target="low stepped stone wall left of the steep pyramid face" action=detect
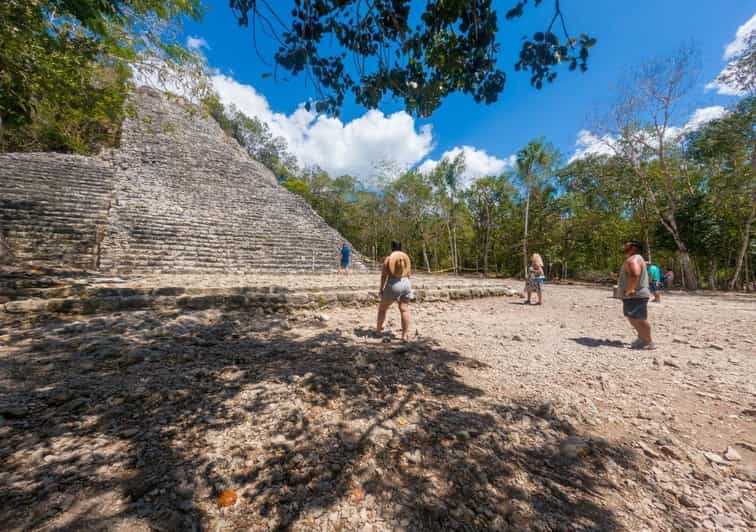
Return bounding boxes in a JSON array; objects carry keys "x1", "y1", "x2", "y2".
[{"x1": 0, "y1": 153, "x2": 114, "y2": 270}]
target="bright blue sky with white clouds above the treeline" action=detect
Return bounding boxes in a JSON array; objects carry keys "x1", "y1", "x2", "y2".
[{"x1": 179, "y1": 0, "x2": 756, "y2": 183}]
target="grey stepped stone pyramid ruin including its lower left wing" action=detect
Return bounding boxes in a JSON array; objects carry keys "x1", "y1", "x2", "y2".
[{"x1": 0, "y1": 88, "x2": 366, "y2": 274}]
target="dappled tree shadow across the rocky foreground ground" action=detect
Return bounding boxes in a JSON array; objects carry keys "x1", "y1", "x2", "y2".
[{"x1": 0, "y1": 312, "x2": 684, "y2": 530}]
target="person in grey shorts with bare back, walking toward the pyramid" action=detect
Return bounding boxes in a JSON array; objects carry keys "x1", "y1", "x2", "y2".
[{"x1": 375, "y1": 240, "x2": 412, "y2": 342}]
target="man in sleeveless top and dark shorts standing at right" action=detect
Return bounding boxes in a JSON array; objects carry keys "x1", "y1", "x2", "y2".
[{"x1": 619, "y1": 240, "x2": 656, "y2": 349}]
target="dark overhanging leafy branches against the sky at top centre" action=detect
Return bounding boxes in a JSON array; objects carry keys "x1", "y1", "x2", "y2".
[{"x1": 230, "y1": 0, "x2": 596, "y2": 116}]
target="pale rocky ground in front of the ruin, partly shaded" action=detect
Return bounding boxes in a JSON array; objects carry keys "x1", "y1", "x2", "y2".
[{"x1": 0, "y1": 280, "x2": 756, "y2": 531}]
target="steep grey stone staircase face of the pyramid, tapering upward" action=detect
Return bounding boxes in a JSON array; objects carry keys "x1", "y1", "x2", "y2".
[{"x1": 102, "y1": 90, "x2": 370, "y2": 273}]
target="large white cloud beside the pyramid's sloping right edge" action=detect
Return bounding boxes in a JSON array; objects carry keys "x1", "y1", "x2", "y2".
[{"x1": 211, "y1": 74, "x2": 433, "y2": 179}]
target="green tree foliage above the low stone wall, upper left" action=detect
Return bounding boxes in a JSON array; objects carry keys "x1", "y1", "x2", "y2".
[{"x1": 0, "y1": 0, "x2": 200, "y2": 152}]
